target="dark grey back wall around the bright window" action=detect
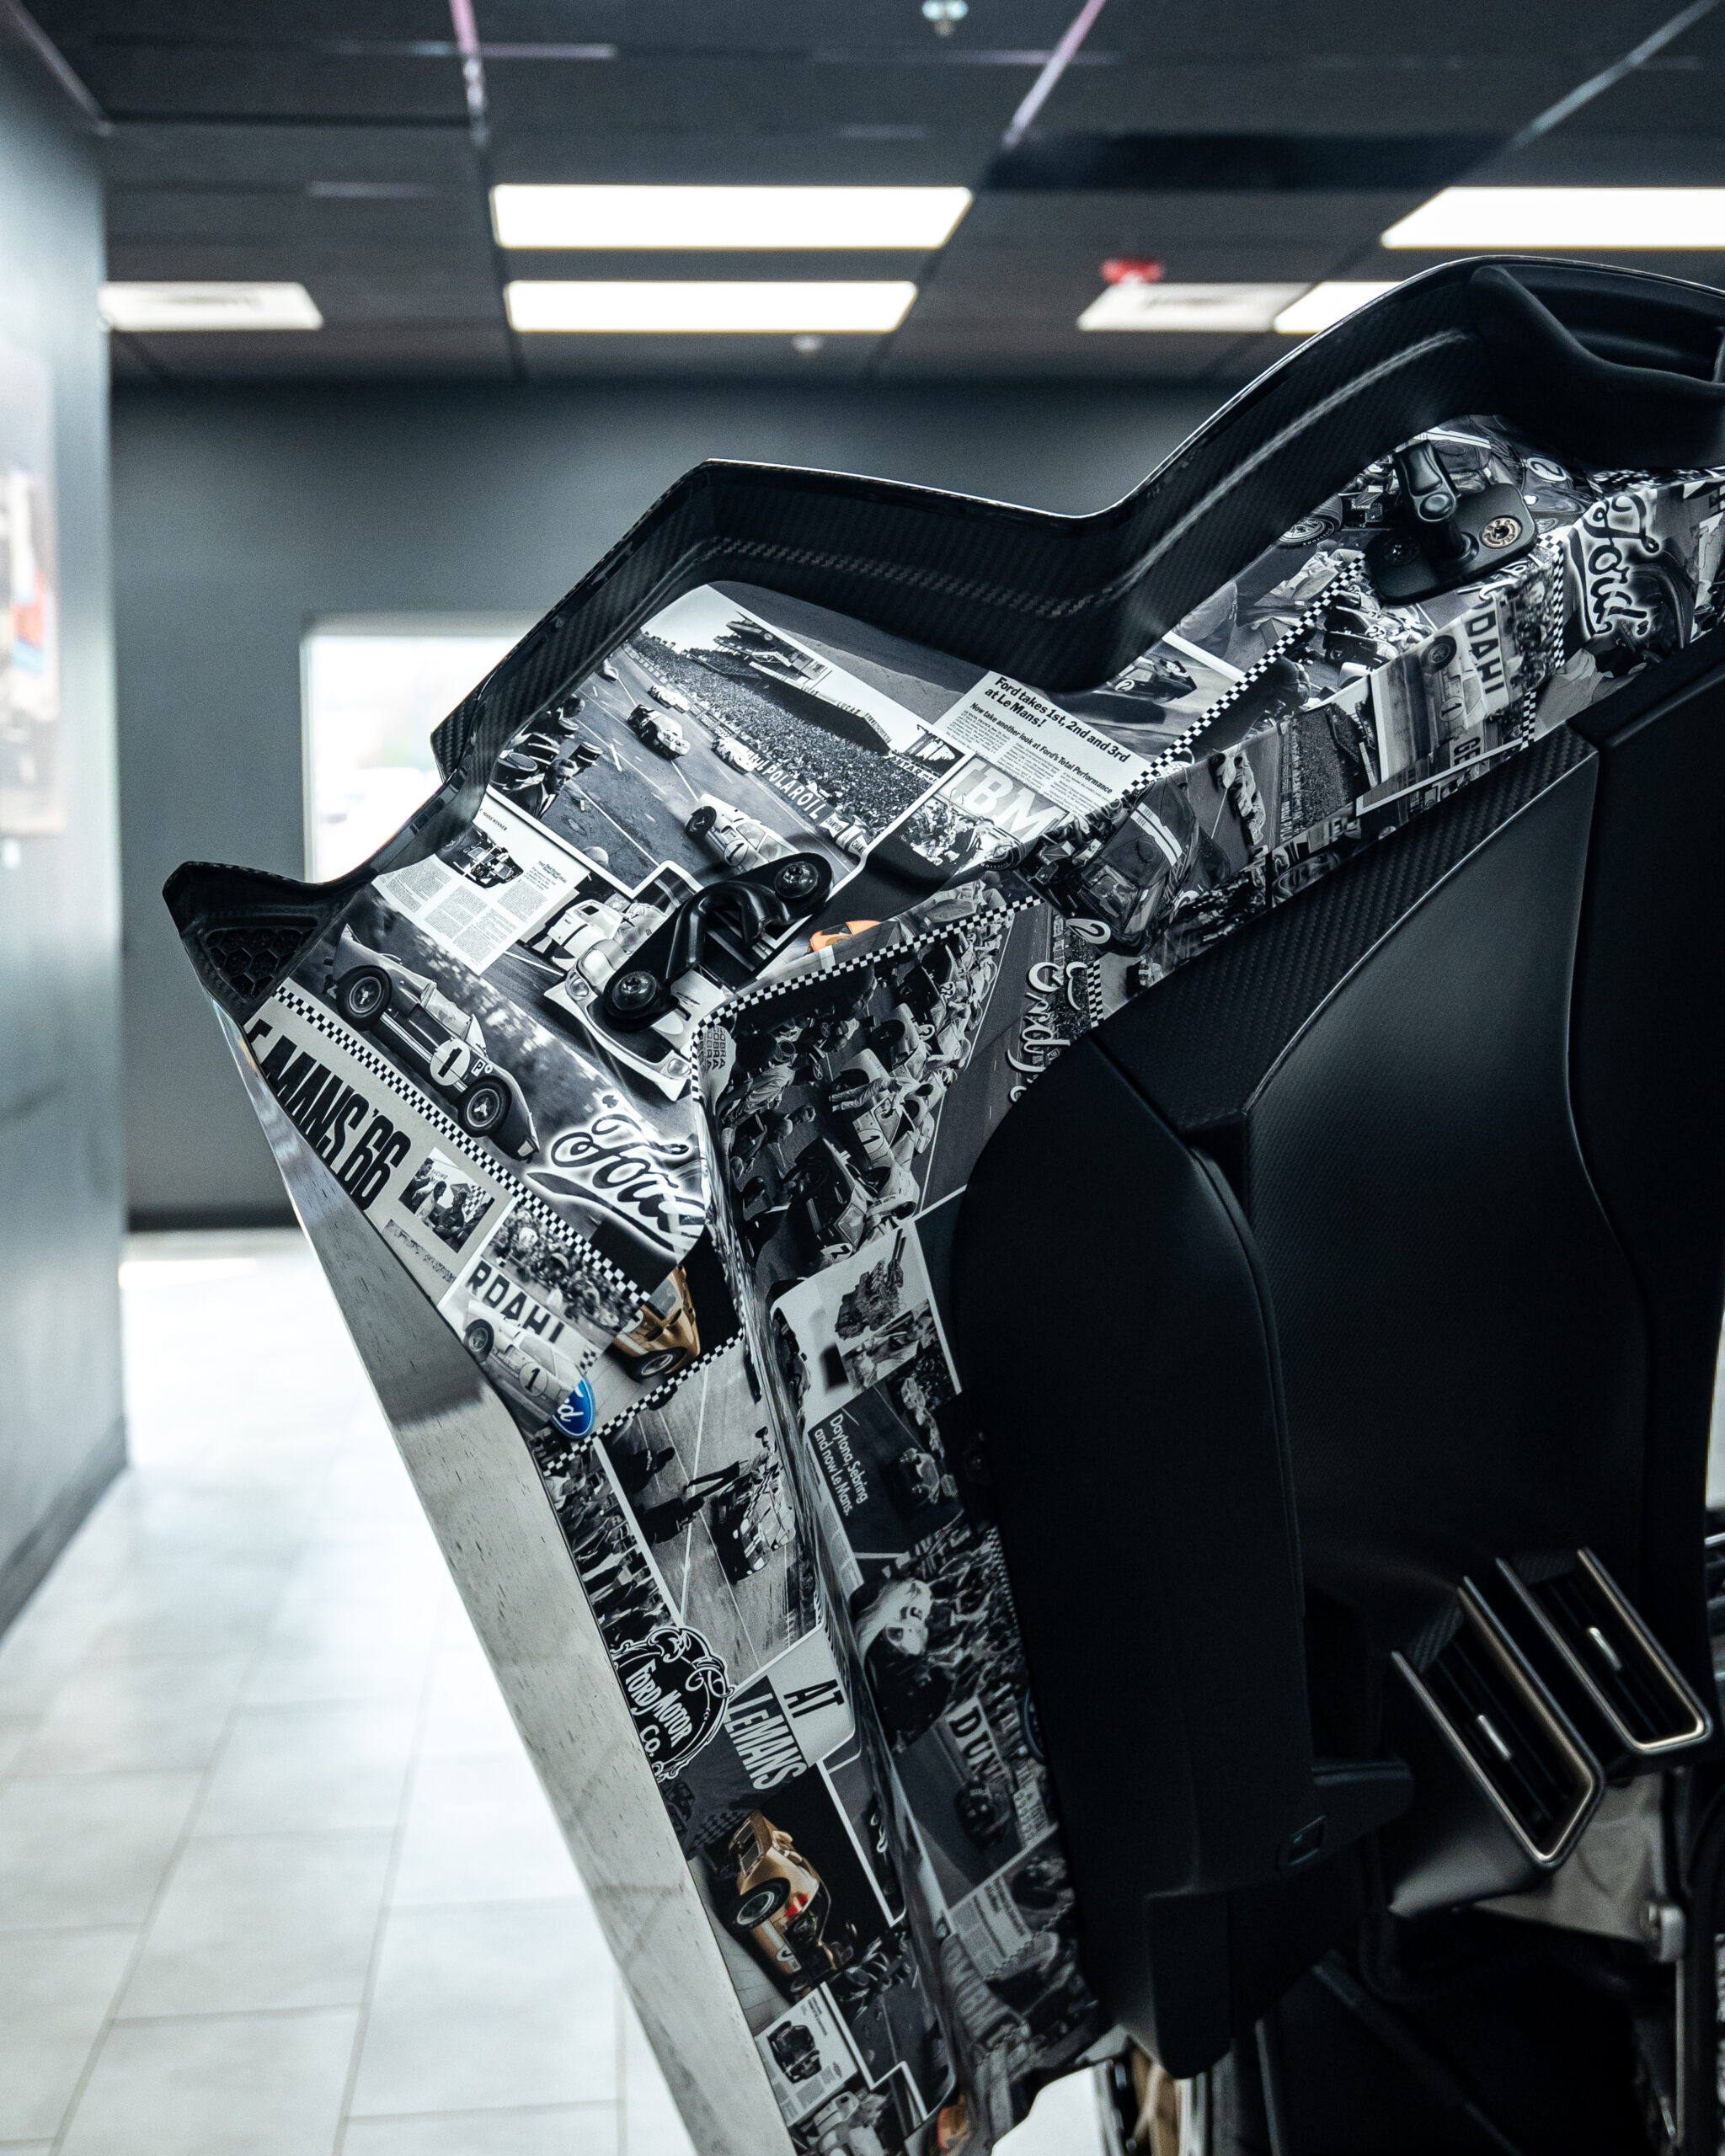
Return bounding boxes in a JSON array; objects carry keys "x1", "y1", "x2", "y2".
[{"x1": 115, "y1": 384, "x2": 1210, "y2": 1220}]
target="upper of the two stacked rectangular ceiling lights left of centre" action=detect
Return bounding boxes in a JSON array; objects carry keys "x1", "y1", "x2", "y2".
[{"x1": 492, "y1": 185, "x2": 970, "y2": 253}]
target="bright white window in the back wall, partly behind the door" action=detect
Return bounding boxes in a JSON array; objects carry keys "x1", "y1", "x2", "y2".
[{"x1": 300, "y1": 615, "x2": 531, "y2": 884}]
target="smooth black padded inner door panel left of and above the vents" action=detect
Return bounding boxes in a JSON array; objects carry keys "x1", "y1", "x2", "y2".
[{"x1": 953, "y1": 643, "x2": 1725, "y2": 2072}]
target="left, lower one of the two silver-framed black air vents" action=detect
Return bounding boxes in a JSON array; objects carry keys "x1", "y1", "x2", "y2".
[{"x1": 1395, "y1": 1580, "x2": 1605, "y2": 1870}]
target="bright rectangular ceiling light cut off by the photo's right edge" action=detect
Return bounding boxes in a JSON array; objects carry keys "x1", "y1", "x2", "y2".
[{"x1": 1385, "y1": 188, "x2": 1725, "y2": 254}]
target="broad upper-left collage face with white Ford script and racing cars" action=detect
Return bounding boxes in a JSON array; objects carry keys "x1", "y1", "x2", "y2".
[{"x1": 252, "y1": 586, "x2": 1172, "y2": 1449}]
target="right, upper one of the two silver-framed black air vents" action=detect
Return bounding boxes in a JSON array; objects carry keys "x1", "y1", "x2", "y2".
[{"x1": 1498, "y1": 1550, "x2": 1712, "y2": 1759}]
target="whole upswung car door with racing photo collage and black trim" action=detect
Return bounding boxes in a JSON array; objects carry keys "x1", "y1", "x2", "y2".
[{"x1": 166, "y1": 263, "x2": 1725, "y2": 2152}]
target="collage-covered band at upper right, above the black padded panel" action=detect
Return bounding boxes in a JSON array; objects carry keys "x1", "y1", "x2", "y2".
[{"x1": 1027, "y1": 419, "x2": 1725, "y2": 1013}]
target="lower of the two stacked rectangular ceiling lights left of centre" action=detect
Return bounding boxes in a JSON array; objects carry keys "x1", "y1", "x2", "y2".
[{"x1": 505, "y1": 278, "x2": 916, "y2": 336}]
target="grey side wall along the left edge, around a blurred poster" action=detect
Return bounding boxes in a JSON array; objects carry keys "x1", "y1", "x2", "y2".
[{"x1": 0, "y1": 39, "x2": 125, "y2": 1625}]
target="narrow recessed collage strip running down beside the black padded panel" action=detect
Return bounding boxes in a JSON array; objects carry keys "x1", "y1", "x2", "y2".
[{"x1": 703, "y1": 931, "x2": 1104, "y2": 2149}]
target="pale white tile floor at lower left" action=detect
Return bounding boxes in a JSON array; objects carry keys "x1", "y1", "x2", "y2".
[{"x1": 0, "y1": 1233, "x2": 1097, "y2": 2156}]
